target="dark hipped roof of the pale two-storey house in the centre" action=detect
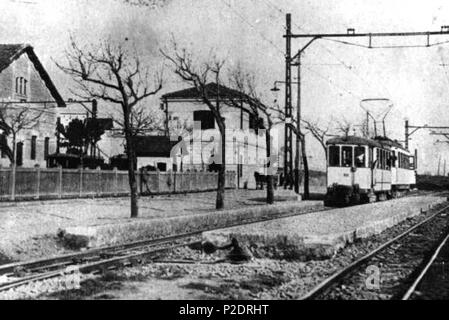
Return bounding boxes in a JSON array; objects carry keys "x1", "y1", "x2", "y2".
[{"x1": 162, "y1": 82, "x2": 245, "y2": 99}]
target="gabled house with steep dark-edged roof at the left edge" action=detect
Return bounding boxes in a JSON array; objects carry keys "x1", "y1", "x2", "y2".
[{"x1": 0, "y1": 44, "x2": 65, "y2": 167}]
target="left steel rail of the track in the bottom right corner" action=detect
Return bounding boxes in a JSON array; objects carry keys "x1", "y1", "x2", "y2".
[{"x1": 299, "y1": 205, "x2": 449, "y2": 300}]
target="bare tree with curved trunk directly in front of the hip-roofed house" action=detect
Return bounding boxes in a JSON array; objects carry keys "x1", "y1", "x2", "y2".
[{"x1": 161, "y1": 42, "x2": 226, "y2": 209}]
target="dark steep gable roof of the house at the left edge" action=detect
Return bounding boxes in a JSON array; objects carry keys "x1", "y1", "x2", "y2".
[{"x1": 0, "y1": 44, "x2": 66, "y2": 107}]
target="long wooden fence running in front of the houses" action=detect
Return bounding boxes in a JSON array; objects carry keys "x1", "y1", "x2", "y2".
[{"x1": 0, "y1": 168, "x2": 236, "y2": 200}]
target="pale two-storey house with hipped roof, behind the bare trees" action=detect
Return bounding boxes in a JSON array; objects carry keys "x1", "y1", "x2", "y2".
[{"x1": 161, "y1": 83, "x2": 266, "y2": 188}]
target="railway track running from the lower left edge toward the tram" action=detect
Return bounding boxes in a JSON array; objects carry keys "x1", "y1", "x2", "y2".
[{"x1": 0, "y1": 193, "x2": 440, "y2": 292}]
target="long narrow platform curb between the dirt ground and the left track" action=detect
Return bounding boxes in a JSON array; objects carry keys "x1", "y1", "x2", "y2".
[{"x1": 59, "y1": 201, "x2": 321, "y2": 249}]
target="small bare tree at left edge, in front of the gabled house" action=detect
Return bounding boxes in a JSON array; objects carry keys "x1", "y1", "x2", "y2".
[{"x1": 0, "y1": 102, "x2": 45, "y2": 166}]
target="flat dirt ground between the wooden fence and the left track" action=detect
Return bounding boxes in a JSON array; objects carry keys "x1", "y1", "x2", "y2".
[{"x1": 0, "y1": 190, "x2": 322, "y2": 263}]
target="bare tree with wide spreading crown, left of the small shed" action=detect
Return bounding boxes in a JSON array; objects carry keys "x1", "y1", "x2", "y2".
[{"x1": 56, "y1": 39, "x2": 162, "y2": 218}]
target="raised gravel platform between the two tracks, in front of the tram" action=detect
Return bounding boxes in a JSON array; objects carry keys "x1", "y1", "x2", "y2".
[{"x1": 203, "y1": 196, "x2": 445, "y2": 261}]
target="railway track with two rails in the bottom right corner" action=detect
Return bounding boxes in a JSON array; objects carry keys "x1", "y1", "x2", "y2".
[{"x1": 300, "y1": 205, "x2": 449, "y2": 300}]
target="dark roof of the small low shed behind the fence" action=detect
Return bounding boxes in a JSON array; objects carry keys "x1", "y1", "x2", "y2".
[{"x1": 134, "y1": 136, "x2": 178, "y2": 158}]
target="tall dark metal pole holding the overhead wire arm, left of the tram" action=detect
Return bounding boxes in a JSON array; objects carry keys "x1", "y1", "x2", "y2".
[{"x1": 284, "y1": 13, "x2": 292, "y2": 189}]
